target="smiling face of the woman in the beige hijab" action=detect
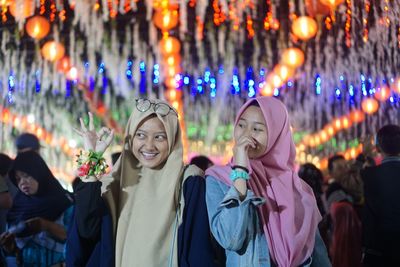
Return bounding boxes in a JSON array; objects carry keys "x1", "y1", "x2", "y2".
[{"x1": 132, "y1": 117, "x2": 169, "y2": 169}]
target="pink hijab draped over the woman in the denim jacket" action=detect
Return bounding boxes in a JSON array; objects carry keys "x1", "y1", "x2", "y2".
[{"x1": 206, "y1": 97, "x2": 321, "y2": 267}]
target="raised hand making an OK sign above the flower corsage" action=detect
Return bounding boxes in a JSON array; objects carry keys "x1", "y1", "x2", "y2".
[{"x1": 74, "y1": 112, "x2": 114, "y2": 153}]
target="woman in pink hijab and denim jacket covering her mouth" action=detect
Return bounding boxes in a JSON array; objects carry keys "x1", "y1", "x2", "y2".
[{"x1": 206, "y1": 97, "x2": 331, "y2": 267}]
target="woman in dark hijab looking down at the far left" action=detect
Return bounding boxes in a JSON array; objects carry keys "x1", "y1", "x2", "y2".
[{"x1": 0, "y1": 151, "x2": 73, "y2": 267}]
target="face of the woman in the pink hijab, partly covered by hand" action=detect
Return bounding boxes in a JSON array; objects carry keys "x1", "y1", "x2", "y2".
[{"x1": 234, "y1": 105, "x2": 268, "y2": 159}]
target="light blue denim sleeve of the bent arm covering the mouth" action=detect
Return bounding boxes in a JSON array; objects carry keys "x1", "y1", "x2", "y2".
[{"x1": 206, "y1": 176, "x2": 265, "y2": 251}]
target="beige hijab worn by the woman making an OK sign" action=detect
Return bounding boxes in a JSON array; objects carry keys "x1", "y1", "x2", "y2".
[{"x1": 102, "y1": 100, "x2": 201, "y2": 267}]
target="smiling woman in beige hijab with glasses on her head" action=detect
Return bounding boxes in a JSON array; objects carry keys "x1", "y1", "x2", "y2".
[{"x1": 67, "y1": 99, "x2": 222, "y2": 267}]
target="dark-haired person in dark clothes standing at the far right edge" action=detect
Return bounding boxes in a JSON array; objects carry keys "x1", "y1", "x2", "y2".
[{"x1": 361, "y1": 124, "x2": 400, "y2": 267}]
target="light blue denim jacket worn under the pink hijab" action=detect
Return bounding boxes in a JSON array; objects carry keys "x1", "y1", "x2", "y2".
[{"x1": 206, "y1": 176, "x2": 331, "y2": 267}]
